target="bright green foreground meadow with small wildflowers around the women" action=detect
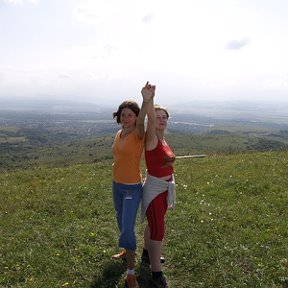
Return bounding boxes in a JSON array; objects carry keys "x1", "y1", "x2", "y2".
[{"x1": 0, "y1": 152, "x2": 288, "y2": 288}]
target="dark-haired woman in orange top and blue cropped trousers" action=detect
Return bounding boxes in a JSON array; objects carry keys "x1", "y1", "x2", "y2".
[{"x1": 112, "y1": 82, "x2": 155, "y2": 288}]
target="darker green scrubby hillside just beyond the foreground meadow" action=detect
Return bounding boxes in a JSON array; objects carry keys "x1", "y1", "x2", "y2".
[{"x1": 0, "y1": 130, "x2": 288, "y2": 171}]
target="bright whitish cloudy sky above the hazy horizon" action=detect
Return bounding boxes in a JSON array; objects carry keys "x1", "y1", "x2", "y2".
[{"x1": 0, "y1": 0, "x2": 288, "y2": 105}]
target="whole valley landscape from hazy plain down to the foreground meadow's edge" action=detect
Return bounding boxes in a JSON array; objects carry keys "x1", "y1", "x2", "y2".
[{"x1": 0, "y1": 109, "x2": 288, "y2": 171}]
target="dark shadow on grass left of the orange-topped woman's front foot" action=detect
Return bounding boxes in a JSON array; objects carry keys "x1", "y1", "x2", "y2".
[{"x1": 90, "y1": 261, "x2": 127, "y2": 288}]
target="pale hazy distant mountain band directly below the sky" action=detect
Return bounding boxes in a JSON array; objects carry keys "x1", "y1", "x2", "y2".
[{"x1": 0, "y1": 97, "x2": 288, "y2": 124}]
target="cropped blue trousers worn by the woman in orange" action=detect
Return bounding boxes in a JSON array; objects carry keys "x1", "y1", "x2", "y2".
[{"x1": 112, "y1": 181, "x2": 142, "y2": 251}]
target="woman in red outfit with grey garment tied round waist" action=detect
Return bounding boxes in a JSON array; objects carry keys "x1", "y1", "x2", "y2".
[{"x1": 142, "y1": 92, "x2": 175, "y2": 287}]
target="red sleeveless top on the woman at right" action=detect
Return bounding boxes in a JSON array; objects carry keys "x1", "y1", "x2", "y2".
[{"x1": 145, "y1": 139, "x2": 175, "y2": 177}]
